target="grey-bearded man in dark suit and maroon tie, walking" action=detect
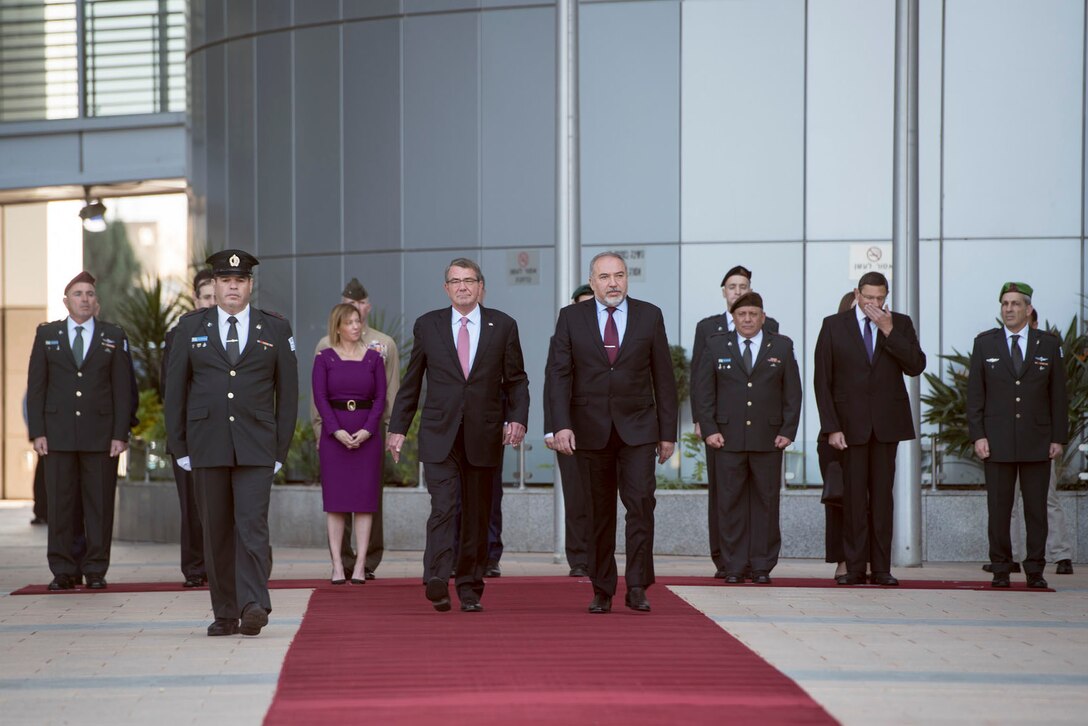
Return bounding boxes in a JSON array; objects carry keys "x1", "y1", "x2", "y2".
[{"x1": 547, "y1": 253, "x2": 677, "y2": 614}]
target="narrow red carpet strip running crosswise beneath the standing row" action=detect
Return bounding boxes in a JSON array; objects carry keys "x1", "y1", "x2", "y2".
[{"x1": 11, "y1": 576, "x2": 1054, "y2": 596}]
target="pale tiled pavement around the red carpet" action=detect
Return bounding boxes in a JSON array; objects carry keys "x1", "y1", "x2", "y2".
[{"x1": 0, "y1": 502, "x2": 1088, "y2": 726}]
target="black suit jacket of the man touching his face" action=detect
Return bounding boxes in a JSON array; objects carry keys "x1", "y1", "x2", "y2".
[{"x1": 813, "y1": 308, "x2": 926, "y2": 445}]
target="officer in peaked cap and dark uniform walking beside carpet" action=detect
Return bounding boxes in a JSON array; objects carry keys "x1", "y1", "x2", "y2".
[{"x1": 165, "y1": 249, "x2": 298, "y2": 636}]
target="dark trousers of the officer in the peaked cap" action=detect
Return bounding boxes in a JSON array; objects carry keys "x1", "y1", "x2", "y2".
[{"x1": 193, "y1": 466, "x2": 272, "y2": 618}]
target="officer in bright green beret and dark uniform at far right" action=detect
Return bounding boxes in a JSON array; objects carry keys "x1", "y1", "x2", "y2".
[{"x1": 967, "y1": 282, "x2": 1068, "y2": 589}]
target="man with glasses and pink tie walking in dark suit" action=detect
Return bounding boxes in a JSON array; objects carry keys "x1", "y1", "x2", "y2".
[{"x1": 386, "y1": 258, "x2": 529, "y2": 613}]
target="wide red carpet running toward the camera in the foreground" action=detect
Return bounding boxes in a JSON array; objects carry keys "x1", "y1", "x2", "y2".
[{"x1": 265, "y1": 577, "x2": 836, "y2": 725}]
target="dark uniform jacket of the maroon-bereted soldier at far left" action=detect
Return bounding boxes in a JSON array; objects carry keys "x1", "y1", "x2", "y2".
[{"x1": 26, "y1": 318, "x2": 133, "y2": 452}]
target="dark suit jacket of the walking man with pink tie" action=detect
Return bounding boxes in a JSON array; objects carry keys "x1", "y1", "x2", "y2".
[{"x1": 390, "y1": 305, "x2": 529, "y2": 467}]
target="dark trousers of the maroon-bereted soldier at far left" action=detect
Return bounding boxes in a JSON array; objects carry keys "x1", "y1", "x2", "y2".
[{"x1": 45, "y1": 451, "x2": 118, "y2": 577}]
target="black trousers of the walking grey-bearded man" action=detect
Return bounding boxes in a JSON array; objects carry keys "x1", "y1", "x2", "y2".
[{"x1": 574, "y1": 427, "x2": 657, "y2": 596}]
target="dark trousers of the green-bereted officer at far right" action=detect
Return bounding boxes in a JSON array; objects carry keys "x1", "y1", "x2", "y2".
[{"x1": 984, "y1": 460, "x2": 1050, "y2": 575}]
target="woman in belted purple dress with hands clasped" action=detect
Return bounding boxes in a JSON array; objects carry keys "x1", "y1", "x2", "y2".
[{"x1": 313, "y1": 305, "x2": 385, "y2": 585}]
